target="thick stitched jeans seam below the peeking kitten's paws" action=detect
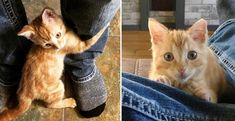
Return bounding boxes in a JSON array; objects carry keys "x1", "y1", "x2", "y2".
[{"x1": 122, "y1": 87, "x2": 204, "y2": 121}]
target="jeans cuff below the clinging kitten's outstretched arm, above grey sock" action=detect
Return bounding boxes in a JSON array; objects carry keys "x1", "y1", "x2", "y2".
[{"x1": 64, "y1": 29, "x2": 108, "y2": 81}]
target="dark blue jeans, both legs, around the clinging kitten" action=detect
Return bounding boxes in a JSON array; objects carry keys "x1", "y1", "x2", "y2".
[{"x1": 0, "y1": 0, "x2": 120, "y2": 86}]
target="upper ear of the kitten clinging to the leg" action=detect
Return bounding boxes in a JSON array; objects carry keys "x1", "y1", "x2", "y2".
[{"x1": 42, "y1": 8, "x2": 57, "y2": 24}]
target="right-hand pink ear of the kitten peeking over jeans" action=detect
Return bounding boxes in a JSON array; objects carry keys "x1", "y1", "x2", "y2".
[{"x1": 189, "y1": 19, "x2": 208, "y2": 43}]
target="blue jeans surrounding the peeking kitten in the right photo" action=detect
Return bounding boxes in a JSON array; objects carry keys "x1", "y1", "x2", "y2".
[{"x1": 122, "y1": 19, "x2": 235, "y2": 121}]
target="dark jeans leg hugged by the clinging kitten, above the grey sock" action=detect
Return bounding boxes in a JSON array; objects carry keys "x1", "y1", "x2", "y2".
[{"x1": 61, "y1": 0, "x2": 120, "y2": 80}]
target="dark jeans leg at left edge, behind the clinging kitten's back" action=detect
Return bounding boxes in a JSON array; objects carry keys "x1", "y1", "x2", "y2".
[{"x1": 0, "y1": 0, "x2": 31, "y2": 110}]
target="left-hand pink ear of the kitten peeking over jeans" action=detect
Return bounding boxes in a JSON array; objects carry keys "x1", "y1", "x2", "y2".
[{"x1": 148, "y1": 18, "x2": 168, "y2": 44}]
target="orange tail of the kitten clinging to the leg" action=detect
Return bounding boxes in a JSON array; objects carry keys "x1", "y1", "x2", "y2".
[{"x1": 0, "y1": 98, "x2": 32, "y2": 121}]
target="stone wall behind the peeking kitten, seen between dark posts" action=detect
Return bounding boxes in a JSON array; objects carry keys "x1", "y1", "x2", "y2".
[{"x1": 122, "y1": 0, "x2": 219, "y2": 25}]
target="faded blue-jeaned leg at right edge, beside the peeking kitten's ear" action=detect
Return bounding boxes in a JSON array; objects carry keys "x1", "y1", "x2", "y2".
[{"x1": 208, "y1": 0, "x2": 235, "y2": 89}]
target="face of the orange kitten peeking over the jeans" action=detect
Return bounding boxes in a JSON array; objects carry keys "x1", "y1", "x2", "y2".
[{"x1": 149, "y1": 19, "x2": 208, "y2": 82}]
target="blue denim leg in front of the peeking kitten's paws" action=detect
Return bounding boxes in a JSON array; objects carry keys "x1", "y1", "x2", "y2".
[{"x1": 122, "y1": 73, "x2": 235, "y2": 121}]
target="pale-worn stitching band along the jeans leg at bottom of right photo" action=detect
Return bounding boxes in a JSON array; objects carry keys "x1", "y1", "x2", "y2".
[{"x1": 122, "y1": 87, "x2": 204, "y2": 121}]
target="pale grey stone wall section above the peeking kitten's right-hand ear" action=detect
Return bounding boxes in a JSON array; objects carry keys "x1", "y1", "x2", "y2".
[{"x1": 184, "y1": 0, "x2": 219, "y2": 25}]
